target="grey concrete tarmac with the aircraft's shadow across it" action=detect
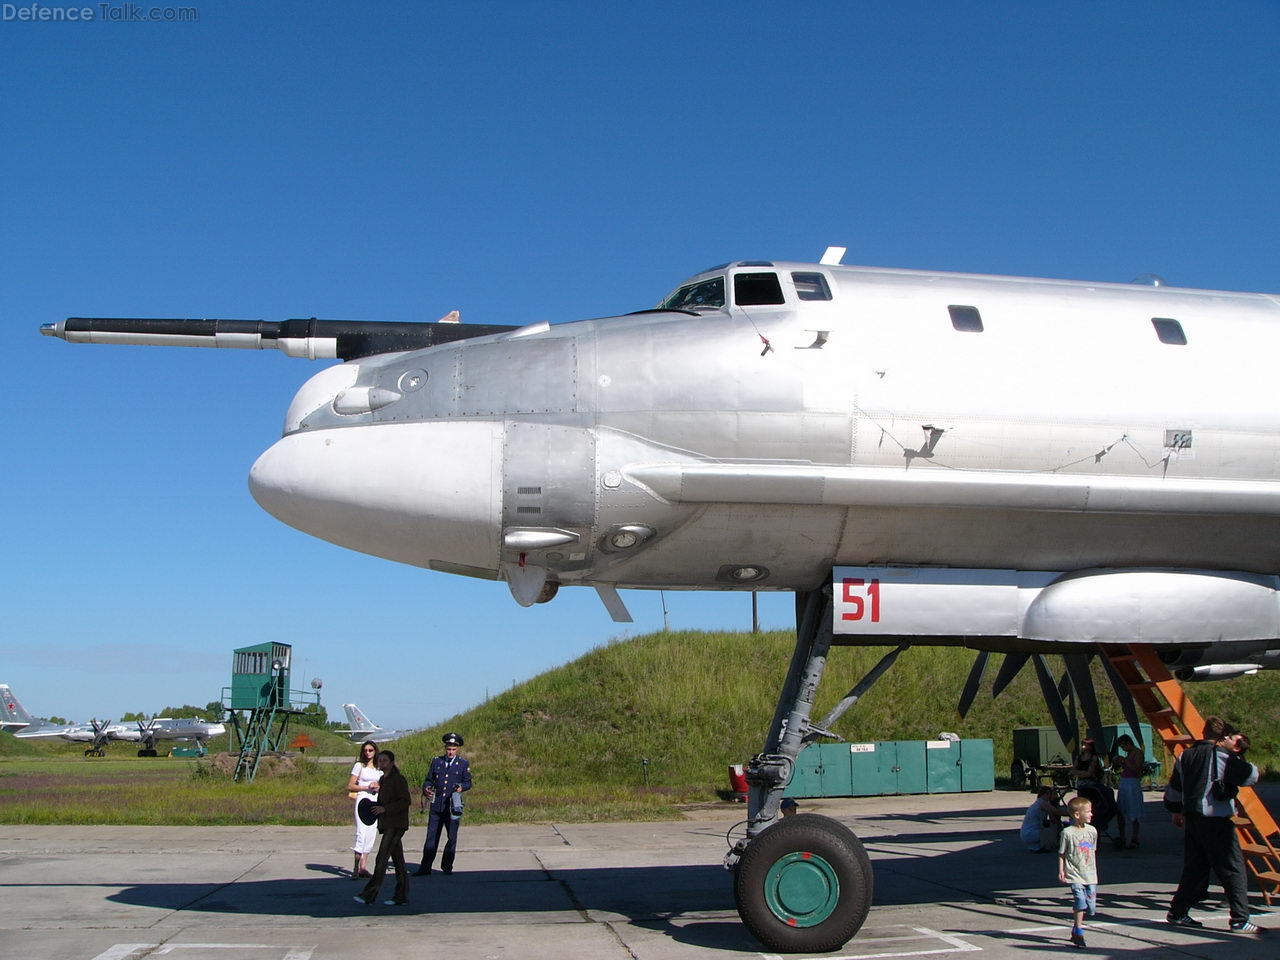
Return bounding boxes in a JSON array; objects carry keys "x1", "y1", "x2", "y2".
[{"x1": 0, "y1": 790, "x2": 1280, "y2": 960}]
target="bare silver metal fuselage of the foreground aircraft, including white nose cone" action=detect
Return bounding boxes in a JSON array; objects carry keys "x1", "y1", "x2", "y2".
[{"x1": 251, "y1": 264, "x2": 1280, "y2": 609}]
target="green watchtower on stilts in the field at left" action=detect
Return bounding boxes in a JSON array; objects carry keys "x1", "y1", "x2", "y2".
[{"x1": 223, "y1": 643, "x2": 320, "y2": 781}]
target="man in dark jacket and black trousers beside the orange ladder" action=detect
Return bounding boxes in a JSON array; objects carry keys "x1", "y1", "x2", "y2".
[{"x1": 1165, "y1": 717, "x2": 1261, "y2": 933}]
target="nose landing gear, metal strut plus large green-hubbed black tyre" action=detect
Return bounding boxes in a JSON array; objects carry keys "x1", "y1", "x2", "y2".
[{"x1": 724, "y1": 586, "x2": 875, "y2": 954}]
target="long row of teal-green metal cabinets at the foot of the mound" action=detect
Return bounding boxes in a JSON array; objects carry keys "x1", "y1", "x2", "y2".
[{"x1": 785, "y1": 740, "x2": 996, "y2": 797}]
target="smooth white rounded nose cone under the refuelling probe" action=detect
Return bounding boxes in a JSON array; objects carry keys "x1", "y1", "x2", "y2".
[{"x1": 248, "y1": 421, "x2": 502, "y2": 570}]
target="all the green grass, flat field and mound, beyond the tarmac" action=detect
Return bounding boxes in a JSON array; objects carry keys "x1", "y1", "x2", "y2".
[{"x1": 0, "y1": 632, "x2": 1280, "y2": 824}]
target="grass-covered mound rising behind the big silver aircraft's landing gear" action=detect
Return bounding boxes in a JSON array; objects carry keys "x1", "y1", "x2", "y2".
[{"x1": 384, "y1": 631, "x2": 1280, "y2": 820}]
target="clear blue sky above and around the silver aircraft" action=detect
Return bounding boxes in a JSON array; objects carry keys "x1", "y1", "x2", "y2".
[{"x1": 0, "y1": 0, "x2": 1280, "y2": 724}]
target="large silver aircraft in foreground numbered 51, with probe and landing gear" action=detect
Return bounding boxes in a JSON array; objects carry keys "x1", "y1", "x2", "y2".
[{"x1": 41, "y1": 256, "x2": 1280, "y2": 951}]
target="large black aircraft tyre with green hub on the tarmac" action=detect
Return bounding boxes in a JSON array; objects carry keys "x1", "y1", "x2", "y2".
[{"x1": 733, "y1": 814, "x2": 872, "y2": 954}]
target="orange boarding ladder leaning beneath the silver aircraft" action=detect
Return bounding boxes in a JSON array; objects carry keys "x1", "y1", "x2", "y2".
[{"x1": 1102, "y1": 644, "x2": 1280, "y2": 906}]
